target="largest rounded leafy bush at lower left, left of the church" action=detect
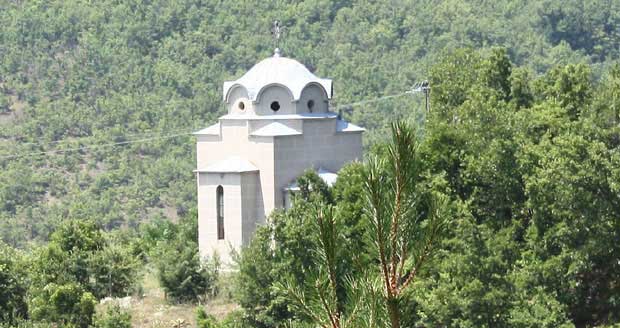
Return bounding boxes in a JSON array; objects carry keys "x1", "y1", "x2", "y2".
[{"x1": 19, "y1": 220, "x2": 139, "y2": 327}]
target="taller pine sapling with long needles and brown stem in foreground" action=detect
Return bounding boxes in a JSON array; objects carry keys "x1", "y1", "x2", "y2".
[{"x1": 364, "y1": 123, "x2": 449, "y2": 328}]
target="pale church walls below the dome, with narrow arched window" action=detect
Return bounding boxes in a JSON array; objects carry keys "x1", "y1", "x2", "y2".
[{"x1": 197, "y1": 115, "x2": 362, "y2": 264}]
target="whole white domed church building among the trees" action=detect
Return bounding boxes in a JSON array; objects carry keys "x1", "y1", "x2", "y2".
[{"x1": 194, "y1": 49, "x2": 364, "y2": 266}]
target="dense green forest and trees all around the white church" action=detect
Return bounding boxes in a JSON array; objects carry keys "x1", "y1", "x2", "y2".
[{"x1": 0, "y1": 0, "x2": 620, "y2": 328}]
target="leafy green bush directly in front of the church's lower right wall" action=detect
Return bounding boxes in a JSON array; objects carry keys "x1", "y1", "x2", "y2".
[{"x1": 235, "y1": 168, "x2": 368, "y2": 327}]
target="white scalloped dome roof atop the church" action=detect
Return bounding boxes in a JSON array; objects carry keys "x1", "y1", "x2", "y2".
[{"x1": 224, "y1": 53, "x2": 332, "y2": 102}]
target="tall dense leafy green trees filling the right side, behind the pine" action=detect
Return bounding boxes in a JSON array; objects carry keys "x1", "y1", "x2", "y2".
[{"x1": 413, "y1": 47, "x2": 620, "y2": 327}]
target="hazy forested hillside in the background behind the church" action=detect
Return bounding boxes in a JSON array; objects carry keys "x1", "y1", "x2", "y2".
[{"x1": 0, "y1": 0, "x2": 620, "y2": 245}]
